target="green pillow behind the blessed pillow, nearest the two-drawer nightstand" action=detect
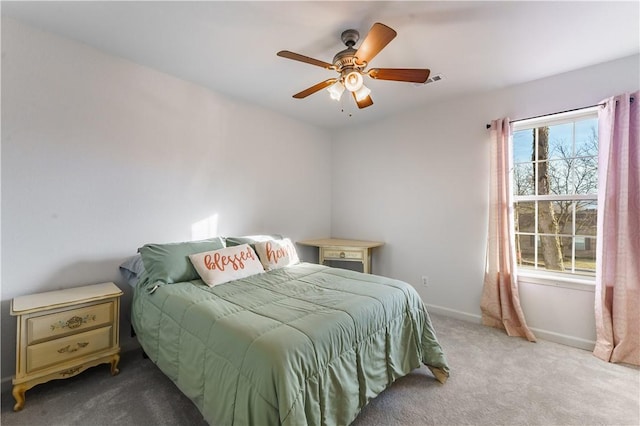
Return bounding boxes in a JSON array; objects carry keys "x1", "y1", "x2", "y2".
[{"x1": 138, "y1": 237, "x2": 224, "y2": 284}]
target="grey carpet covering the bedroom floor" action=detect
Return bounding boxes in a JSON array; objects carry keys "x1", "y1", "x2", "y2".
[{"x1": 1, "y1": 315, "x2": 640, "y2": 426}]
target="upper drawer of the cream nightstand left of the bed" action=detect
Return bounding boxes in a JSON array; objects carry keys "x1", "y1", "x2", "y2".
[{"x1": 27, "y1": 302, "x2": 113, "y2": 345}]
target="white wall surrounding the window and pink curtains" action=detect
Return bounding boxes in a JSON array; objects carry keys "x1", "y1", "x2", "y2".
[{"x1": 331, "y1": 56, "x2": 640, "y2": 347}]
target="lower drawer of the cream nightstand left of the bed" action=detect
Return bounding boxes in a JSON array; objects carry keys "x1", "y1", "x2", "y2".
[{"x1": 27, "y1": 326, "x2": 112, "y2": 372}]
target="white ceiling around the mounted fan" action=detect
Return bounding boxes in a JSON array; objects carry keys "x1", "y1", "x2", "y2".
[{"x1": 1, "y1": 1, "x2": 640, "y2": 128}]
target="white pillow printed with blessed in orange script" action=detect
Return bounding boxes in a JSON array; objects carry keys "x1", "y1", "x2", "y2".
[{"x1": 189, "y1": 244, "x2": 264, "y2": 287}]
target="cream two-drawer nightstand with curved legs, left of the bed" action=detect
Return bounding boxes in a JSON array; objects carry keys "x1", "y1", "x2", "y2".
[{"x1": 11, "y1": 283, "x2": 122, "y2": 411}]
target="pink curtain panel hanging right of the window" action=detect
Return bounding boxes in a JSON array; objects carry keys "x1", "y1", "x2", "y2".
[{"x1": 593, "y1": 92, "x2": 640, "y2": 365}]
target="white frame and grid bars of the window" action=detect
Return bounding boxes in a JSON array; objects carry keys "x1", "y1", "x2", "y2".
[{"x1": 509, "y1": 106, "x2": 599, "y2": 291}]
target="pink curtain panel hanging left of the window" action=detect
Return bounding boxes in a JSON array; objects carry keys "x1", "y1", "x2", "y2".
[{"x1": 480, "y1": 118, "x2": 536, "y2": 342}]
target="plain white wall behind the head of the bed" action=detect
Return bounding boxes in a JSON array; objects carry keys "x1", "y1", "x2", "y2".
[{"x1": 1, "y1": 19, "x2": 331, "y2": 378}]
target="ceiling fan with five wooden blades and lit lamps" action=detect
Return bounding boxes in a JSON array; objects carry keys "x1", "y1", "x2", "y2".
[{"x1": 277, "y1": 22, "x2": 430, "y2": 108}]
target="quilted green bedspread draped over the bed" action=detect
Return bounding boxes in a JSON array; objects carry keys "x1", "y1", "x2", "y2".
[{"x1": 132, "y1": 263, "x2": 449, "y2": 425}]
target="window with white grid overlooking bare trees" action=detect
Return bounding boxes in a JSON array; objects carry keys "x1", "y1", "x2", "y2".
[{"x1": 512, "y1": 107, "x2": 598, "y2": 277}]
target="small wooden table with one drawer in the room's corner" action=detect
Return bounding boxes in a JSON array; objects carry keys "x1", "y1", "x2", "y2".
[{"x1": 298, "y1": 238, "x2": 384, "y2": 274}]
